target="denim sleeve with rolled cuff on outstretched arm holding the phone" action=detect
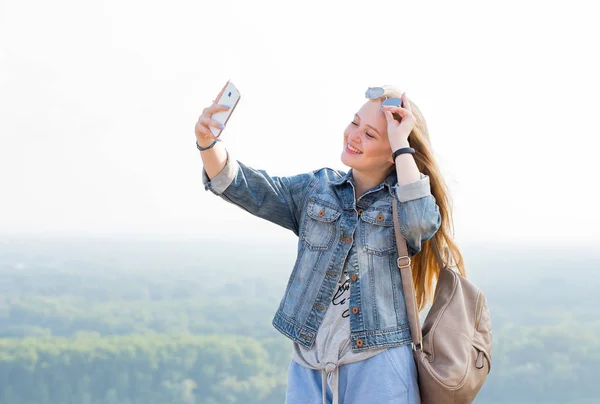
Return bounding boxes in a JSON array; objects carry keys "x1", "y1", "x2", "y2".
[{"x1": 202, "y1": 151, "x2": 315, "y2": 235}]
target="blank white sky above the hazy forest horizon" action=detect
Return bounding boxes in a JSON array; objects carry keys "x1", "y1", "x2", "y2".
[{"x1": 0, "y1": 0, "x2": 600, "y2": 242}]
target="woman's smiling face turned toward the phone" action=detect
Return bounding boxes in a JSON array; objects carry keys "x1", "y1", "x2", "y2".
[{"x1": 341, "y1": 100, "x2": 394, "y2": 175}]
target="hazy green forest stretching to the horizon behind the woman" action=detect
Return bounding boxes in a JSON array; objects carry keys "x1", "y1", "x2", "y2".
[{"x1": 0, "y1": 239, "x2": 600, "y2": 404}]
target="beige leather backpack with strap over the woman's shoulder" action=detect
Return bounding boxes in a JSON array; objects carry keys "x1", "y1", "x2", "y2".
[{"x1": 394, "y1": 198, "x2": 492, "y2": 404}]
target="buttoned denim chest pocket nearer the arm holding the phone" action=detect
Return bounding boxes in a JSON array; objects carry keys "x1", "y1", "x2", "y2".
[{"x1": 302, "y1": 198, "x2": 342, "y2": 250}]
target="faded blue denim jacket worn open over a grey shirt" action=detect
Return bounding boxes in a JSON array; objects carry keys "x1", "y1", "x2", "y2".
[{"x1": 202, "y1": 152, "x2": 441, "y2": 352}]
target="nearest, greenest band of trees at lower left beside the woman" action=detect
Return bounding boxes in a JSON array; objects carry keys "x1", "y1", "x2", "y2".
[{"x1": 0, "y1": 334, "x2": 289, "y2": 404}]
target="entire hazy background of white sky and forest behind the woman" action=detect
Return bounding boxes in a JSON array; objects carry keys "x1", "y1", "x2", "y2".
[{"x1": 0, "y1": 0, "x2": 600, "y2": 404}]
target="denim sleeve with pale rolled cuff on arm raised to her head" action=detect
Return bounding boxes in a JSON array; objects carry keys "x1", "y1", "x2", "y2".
[{"x1": 395, "y1": 173, "x2": 442, "y2": 256}]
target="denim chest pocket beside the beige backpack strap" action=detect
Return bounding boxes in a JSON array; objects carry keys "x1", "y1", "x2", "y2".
[{"x1": 360, "y1": 209, "x2": 396, "y2": 255}]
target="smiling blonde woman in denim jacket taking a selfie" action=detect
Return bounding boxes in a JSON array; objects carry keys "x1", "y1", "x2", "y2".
[{"x1": 195, "y1": 86, "x2": 464, "y2": 404}]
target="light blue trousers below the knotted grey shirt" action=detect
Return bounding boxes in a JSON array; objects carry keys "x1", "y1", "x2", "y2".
[{"x1": 285, "y1": 345, "x2": 421, "y2": 404}]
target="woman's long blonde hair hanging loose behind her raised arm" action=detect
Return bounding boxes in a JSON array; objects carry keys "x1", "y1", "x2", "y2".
[{"x1": 381, "y1": 85, "x2": 466, "y2": 311}]
